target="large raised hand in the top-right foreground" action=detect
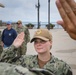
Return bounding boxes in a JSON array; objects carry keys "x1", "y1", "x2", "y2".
[{"x1": 56, "y1": 0, "x2": 76, "y2": 40}]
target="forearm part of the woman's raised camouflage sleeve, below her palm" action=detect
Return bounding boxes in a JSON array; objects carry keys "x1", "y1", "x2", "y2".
[{"x1": 0, "y1": 45, "x2": 16, "y2": 62}]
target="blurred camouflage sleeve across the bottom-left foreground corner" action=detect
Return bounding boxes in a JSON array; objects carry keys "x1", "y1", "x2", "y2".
[{"x1": 0, "y1": 63, "x2": 37, "y2": 75}]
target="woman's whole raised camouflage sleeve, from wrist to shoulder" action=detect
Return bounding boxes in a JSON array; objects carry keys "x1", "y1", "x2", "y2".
[{"x1": 0, "y1": 45, "x2": 31, "y2": 68}]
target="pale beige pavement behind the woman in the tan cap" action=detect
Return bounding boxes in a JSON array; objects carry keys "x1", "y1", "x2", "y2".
[{"x1": 26, "y1": 29, "x2": 76, "y2": 75}]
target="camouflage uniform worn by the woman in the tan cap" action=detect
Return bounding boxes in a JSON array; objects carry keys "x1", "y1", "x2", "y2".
[{"x1": 1, "y1": 46, "x2": 72, "y2": 75}]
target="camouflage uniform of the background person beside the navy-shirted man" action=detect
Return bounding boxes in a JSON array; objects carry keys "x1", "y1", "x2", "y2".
[{"x1": 16, "y1": 26, "x2": 30, "y2": 56}]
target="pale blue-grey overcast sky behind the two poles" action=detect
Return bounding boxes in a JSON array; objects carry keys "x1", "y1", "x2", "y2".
[{"x1": 0, "y1": 0, "x2": 61, "y2": 22}]
